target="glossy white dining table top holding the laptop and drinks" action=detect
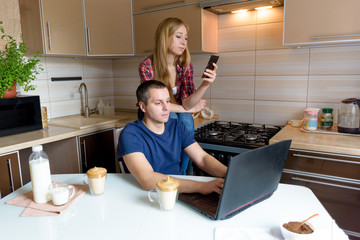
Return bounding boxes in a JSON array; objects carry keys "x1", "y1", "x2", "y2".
[{"x1": 0, "y1": 174, "x2": 344, "y2": 240}]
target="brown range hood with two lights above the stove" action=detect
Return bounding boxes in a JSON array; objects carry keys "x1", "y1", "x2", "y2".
[{"x1": 200, "y1": 0, "x2": 284, "y2": 14}]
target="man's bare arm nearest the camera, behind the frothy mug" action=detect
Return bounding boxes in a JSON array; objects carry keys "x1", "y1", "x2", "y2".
[{"x1": 123, "y1": 152, "x2": 226, "y2": 194}]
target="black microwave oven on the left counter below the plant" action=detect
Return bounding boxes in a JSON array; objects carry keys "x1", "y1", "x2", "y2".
[{"x1": 0, "y1": 96, "x2": 42, "y2": 137}]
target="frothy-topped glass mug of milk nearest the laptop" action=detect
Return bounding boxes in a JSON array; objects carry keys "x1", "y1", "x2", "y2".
[{"x1": 148, "y1": 176, "x2": 179, "y2": 210}]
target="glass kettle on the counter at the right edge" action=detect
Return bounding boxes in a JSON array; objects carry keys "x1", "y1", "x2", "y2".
[{"x1": 338, "y1": 98, "x2": 360, "y2": 134}]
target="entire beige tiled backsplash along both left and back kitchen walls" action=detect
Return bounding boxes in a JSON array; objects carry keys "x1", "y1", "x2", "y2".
[{"x1": 0, "y1": 0, "x2": 360, "y2": 125}]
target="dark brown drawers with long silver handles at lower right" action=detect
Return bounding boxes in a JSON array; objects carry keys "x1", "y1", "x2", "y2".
[{"x1": 281, "y1": 149, "x2": 360, "y2": 239}]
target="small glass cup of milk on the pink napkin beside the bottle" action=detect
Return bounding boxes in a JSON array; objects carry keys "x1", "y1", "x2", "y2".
[{"x1": 49, "y1": 183, "x2": 75, "y2": 206}]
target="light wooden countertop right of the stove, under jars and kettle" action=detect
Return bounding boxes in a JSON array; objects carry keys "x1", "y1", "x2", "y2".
[{"x1": 270, "y1": 125, "x2": 360, "y2": 156}]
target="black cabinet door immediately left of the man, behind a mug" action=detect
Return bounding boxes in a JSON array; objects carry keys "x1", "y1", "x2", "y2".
[{"x1": 78, "y1": 128, "x2": 117, "y2": 173}]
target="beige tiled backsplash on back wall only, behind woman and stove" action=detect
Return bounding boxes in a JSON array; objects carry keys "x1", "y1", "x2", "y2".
[{"x1": 113, "y1": 7, "x2": 360, "y2": 125}]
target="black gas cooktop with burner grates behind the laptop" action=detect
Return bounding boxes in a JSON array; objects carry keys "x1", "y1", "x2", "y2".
[{"x1": 195, "y1": 121, "x2": 281, "y2": 149}]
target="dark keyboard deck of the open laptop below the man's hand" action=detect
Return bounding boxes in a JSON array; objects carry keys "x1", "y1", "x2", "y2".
[{"x1": 179, "y1": 193, "x2": 220, "y2": 216}]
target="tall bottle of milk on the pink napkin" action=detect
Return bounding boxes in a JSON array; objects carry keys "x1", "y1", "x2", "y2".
[{"x1": 29, "y1": 145, "x2": 51, "y2": 203}]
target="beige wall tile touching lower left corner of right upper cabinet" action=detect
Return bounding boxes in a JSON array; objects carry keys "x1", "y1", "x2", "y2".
[{"x1": 256, "y1": 49, "x2": 309, "y2": 76}]
